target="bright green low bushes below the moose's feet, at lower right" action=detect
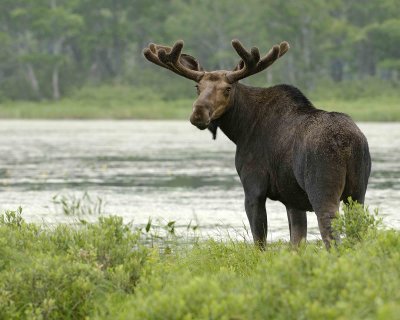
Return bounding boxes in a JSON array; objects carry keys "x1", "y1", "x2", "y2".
[{"x1": 104, "y1": 231, "x2": 400, "y2": 319}]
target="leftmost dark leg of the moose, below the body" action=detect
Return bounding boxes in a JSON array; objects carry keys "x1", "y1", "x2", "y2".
[{"x1": 245, "y1": 194, "x2": 268, "y2": 249}]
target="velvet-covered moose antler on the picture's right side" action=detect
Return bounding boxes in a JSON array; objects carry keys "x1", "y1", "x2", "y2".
[{"x1": 226, "y1": 40, "x2": 289, "y2": 83}]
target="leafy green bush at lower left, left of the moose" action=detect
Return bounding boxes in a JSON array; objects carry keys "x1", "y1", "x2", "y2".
[{"x1": 0, "y1": 211, "x2": 148, "y2": 319}]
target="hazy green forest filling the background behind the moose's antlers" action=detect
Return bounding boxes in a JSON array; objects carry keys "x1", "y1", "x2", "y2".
[{"x1": 0, "y1": 0, "x2": 400, "y2": 100}]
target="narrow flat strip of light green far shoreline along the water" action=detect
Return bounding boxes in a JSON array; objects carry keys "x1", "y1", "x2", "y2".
[{"x1": 0, "y1": 96, "x2": 400, "y2": 122}]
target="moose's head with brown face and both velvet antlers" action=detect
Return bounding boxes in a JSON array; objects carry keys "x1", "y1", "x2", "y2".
[{"x1": 143, "y1": 40, "x2": 289, "y2": 130}]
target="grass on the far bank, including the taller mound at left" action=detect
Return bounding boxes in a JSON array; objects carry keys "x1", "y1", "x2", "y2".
[{"x1": 0, "y1": 86, "x2": 400, "y2": 121}]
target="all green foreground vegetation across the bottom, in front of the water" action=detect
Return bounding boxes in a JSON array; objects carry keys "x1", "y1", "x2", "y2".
[{"x1": 0, "y1": 204, "x2": 400, "y2": 320}]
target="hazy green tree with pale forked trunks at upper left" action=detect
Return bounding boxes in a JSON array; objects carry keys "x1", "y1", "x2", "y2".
[{"x1": 10, "y1": 0, "x2": 83, "y2": 99}]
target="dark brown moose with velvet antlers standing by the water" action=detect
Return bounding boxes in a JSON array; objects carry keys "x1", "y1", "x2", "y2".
[{"x1": 143, "y1": 40, "x2": 371, "y2": 249}]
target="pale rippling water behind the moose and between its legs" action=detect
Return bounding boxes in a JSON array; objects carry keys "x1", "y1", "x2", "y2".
[{"x1": 0, "y1": 120, "x2": 400, "y2": 240}]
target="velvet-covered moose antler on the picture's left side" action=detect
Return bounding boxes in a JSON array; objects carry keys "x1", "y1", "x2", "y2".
[{"x1": 143, "y1": 40, "x2": 204, "y2": 82}]
